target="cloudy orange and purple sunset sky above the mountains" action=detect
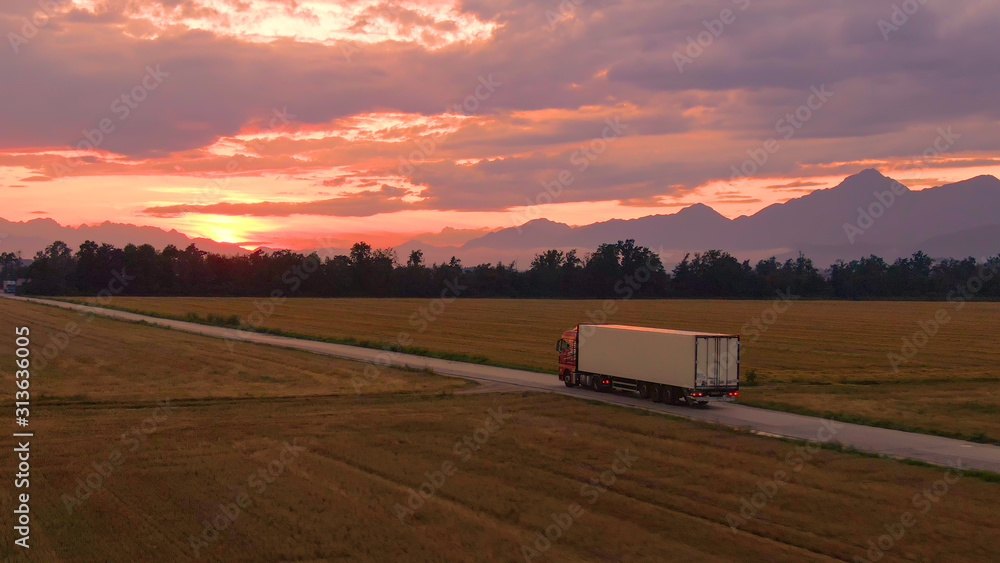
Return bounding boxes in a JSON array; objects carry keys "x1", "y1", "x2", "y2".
[{"x1": 0, "y1": 0, "x2": 1000, "y2": 249}]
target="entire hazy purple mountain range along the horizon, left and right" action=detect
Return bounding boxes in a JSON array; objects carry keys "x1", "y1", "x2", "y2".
[{"x1": 0, "y1": 169, "x2": 1000, "y2": 268}]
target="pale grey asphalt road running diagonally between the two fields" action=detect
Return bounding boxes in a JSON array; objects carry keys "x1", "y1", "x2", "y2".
[{"x1": 5, "y1": 296, "x2": 1000, "y2": 473}]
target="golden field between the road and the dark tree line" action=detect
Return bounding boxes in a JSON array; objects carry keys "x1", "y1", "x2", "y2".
[{"x1": 60, "y1": 297, "x2": 1000, "y2": 442}]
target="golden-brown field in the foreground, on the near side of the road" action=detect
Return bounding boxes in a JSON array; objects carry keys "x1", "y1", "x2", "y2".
[{"x1": 0, "y1": 300, "x2": 1000, "y2": 561}]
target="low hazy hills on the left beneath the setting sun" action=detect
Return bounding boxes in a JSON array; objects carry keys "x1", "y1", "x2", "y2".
[{"x1": 0, "y1": 218, "x2": 247, "y2": 258}]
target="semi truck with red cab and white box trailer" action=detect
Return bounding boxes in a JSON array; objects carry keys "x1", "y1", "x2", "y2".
[{"x1": 556, "y1": 324, "x2": 740, "y2": 407}]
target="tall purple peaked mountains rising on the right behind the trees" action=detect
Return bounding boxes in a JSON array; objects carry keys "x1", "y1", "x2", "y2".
[{"x1": 450, "y1": 169, "x2": 1000, "y2": 267}]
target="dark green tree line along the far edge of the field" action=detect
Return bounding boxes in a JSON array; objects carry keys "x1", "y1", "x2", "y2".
[{"x1": 0, "y1": 240, "x2": 1000, "y2": 300}]
